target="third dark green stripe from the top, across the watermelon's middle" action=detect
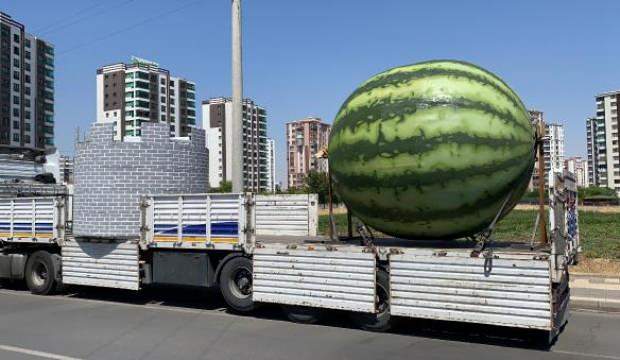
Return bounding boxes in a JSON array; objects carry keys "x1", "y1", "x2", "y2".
[{"x1": 330, "y1": 131, "x2": 531, "y2": 161}]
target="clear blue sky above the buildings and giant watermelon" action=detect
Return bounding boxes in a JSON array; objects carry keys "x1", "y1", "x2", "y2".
[{"x1": 0, "y1": 0, "x2": 620, "y2": 182}]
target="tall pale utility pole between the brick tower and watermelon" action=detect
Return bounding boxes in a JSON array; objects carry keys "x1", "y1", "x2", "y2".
[{"x1": 230, "y1": 0, "x2": 244, "y2": 193}]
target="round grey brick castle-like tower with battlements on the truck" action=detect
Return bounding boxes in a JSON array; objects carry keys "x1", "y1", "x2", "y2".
[{"x1": 73, "y1": 122, "x2": 208, "y2": 239}]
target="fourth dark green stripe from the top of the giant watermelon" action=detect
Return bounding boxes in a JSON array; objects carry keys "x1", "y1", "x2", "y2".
[{"x1": 332, "y1": 148, "x2": 533, "y2": 189}]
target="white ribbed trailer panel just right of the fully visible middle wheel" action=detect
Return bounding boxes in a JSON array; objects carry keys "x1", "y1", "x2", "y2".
[{"x1": 252, "y1": 248, "x2": 376, "y2": 312}]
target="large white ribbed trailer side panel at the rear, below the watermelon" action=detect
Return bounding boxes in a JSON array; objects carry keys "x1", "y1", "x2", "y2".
[{"x1": 389, "y1": 249, "x2": 553, "y2": 330}]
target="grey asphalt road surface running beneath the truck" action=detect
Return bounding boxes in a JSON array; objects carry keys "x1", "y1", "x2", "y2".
[{"x1": 0, "y1": 288, "x2": 620, "y2": 360}]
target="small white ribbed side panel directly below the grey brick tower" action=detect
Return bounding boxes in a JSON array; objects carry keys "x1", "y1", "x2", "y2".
[{"x1": 62, "y1": 240, "x2": 140, "y2": 290}]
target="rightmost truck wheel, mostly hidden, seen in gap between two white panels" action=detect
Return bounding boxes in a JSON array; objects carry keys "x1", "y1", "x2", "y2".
[{"x1": 351, "y1": 270, "x2": 391, "y2": 332}]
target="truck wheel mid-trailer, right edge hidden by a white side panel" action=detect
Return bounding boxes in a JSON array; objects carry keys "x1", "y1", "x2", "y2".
[{"x1": 220, "y1": 256, "x2": 254, "y2": 313}]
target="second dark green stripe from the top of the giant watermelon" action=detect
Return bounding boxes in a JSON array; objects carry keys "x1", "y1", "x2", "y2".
[{"x1": 331, "y1": 98, "x2": 532, "y2": 136}]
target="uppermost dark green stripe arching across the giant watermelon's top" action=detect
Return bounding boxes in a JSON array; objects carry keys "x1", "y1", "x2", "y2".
[{"x1": 343, "y1": 64, "x2": 524, "y2": 115}]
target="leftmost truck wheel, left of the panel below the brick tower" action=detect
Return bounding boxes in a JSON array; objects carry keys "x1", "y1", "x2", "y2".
[{"x1": 24, "y1": 250, "x2": 58, "y2": 295}]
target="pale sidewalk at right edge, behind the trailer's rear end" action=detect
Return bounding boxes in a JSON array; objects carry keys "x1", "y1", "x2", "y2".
[{"x1": 570, "y1": 273, "x2": 620, "y2": 312}]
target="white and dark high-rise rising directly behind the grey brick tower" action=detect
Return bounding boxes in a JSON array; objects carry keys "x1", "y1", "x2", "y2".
[{"x1": 97, "y1": 57, "x2": 196, "y2": 139}]
